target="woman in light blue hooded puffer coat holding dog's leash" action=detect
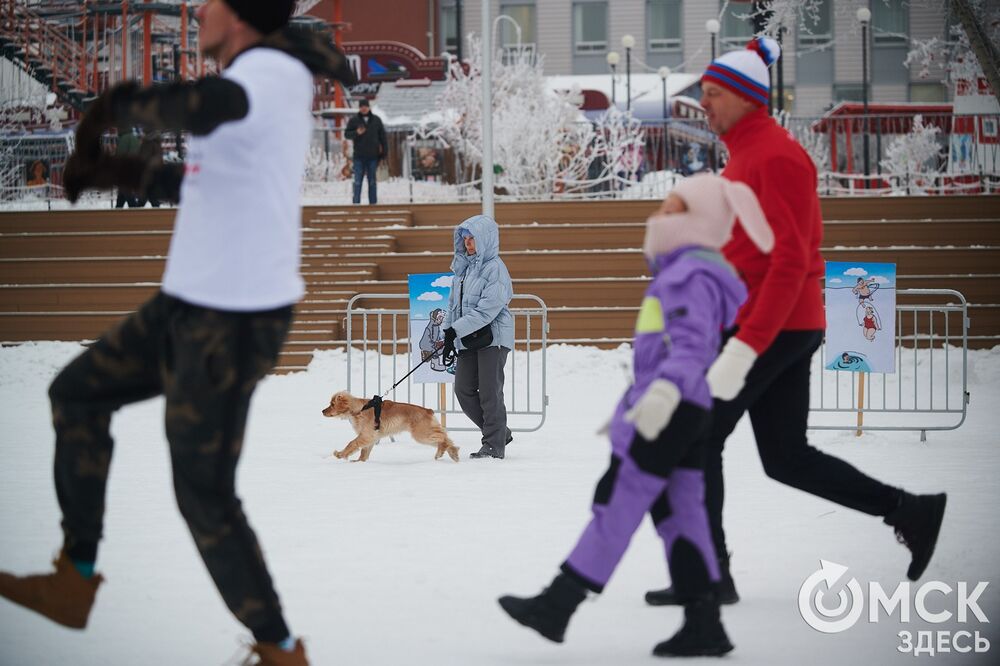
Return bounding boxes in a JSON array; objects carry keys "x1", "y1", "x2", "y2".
[{"x1": 443, "y1": 215, "x2": 514, "y2": 459}]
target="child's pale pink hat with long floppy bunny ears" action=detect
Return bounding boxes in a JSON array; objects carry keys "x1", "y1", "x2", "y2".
[{"x1": 642, "y1": 173, "x2": 774, "y2": 259}]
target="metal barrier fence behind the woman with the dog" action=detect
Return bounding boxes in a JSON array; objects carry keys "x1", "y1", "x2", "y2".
[{"x1": 347, "y1": 294, "x2": 549, "y2": 432}]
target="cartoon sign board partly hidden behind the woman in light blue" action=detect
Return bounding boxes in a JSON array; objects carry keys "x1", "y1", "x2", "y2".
[{"x1": 408, "y1": 273, "x2": 455, "y2": 384}]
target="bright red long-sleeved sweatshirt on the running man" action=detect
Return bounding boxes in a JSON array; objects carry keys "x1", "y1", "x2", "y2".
[{"x1": 722, "y1": 108, "x2": 826, "y2": 354}]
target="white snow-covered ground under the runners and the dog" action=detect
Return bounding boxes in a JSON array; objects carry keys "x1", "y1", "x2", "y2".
[{"x1": 0, "y1": 343, "x2": 1000, "y2": 666}]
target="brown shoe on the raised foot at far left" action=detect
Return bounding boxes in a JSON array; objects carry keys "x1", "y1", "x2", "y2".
[{"x1": 0, "y1": 552, "x2": 104, "y2": 629}]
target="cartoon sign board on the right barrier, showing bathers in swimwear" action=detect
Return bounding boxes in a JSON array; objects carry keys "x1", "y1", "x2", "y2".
[{"x1": 823, "y1": 261, "x2": 896, "y2": 373}]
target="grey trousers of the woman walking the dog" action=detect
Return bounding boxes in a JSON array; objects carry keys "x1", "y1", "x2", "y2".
[{"x1": 455, "y1": 347, "x2": 510, "y2": 455}]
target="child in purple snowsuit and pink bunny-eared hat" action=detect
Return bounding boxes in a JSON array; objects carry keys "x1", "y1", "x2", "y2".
[{"x1": 499, "y1": 174, "x2": 774, "y2": 656}]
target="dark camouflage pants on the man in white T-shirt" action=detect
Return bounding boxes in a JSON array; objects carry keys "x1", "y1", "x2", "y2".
[{"x1": 49, "y1": 293, "x2": 292, "y2": 642}]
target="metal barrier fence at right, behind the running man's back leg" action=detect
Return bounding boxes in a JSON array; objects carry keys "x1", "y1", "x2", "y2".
[{"x1": 809, "y1": 289, "x2": 970, "y2": 441}]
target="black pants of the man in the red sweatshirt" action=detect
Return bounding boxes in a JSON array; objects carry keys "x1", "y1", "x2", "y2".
[{"x1": 704, "y1": 331, "x2": 900, "y2": 558}]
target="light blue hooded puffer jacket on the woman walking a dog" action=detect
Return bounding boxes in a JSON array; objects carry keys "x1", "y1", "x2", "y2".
[{"x1": 443, "y1": 215, "x2": 514, "y2": 350}]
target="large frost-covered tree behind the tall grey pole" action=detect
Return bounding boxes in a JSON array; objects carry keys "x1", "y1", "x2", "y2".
[{"x1": 417, "y1": 35, "x2": 643, "y2": 198}]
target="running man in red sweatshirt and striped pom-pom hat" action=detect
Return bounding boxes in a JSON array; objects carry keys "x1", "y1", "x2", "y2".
[{"x1": 646, "y1": 38, "x2": 946, "y2": 605}]
